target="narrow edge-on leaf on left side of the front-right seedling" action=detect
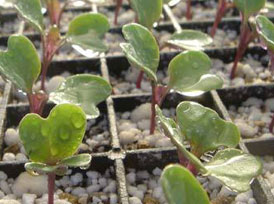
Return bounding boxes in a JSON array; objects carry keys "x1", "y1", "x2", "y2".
[{"x1": 156, "y1": 106, "x2": 207, "y2": 174}]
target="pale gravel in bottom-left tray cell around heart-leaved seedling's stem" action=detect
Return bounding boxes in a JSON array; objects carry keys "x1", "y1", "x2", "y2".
[{"x1": 0, "y1": 167, "x2": 118, "y2": 204}]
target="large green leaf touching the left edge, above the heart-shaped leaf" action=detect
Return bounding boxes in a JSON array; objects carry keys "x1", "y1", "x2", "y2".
[{"x1": 0, "y1": 35, "x2": 41, "y2": 93}]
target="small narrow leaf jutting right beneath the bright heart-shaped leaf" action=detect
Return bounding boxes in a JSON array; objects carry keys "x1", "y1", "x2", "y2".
[{"x1": 59, "y1": 154, "x2": 91, "y2": 167}]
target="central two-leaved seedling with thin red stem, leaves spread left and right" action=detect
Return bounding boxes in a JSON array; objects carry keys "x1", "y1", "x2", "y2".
[{"x1": 120, "y1": 24, "x2": 223, "y2": 134}]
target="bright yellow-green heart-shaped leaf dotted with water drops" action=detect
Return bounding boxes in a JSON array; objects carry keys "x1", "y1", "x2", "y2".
[{"x1": 19, "y1": 104, "x2": 86, "y2": 165}]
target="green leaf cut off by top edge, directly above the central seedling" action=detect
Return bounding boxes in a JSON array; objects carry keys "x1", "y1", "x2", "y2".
[{"x1": 130, "y1": 0, "x2": 163, "y2": 30}]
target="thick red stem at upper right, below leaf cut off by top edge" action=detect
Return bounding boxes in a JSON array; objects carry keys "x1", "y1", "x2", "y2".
[{"x1": 230, "y1": 22, "x2": 252, "y2": 80}]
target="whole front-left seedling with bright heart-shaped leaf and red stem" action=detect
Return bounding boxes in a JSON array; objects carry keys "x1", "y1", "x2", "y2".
[{"x1": 19, "y1": 104, "x2": 91, "y2": 204}]
